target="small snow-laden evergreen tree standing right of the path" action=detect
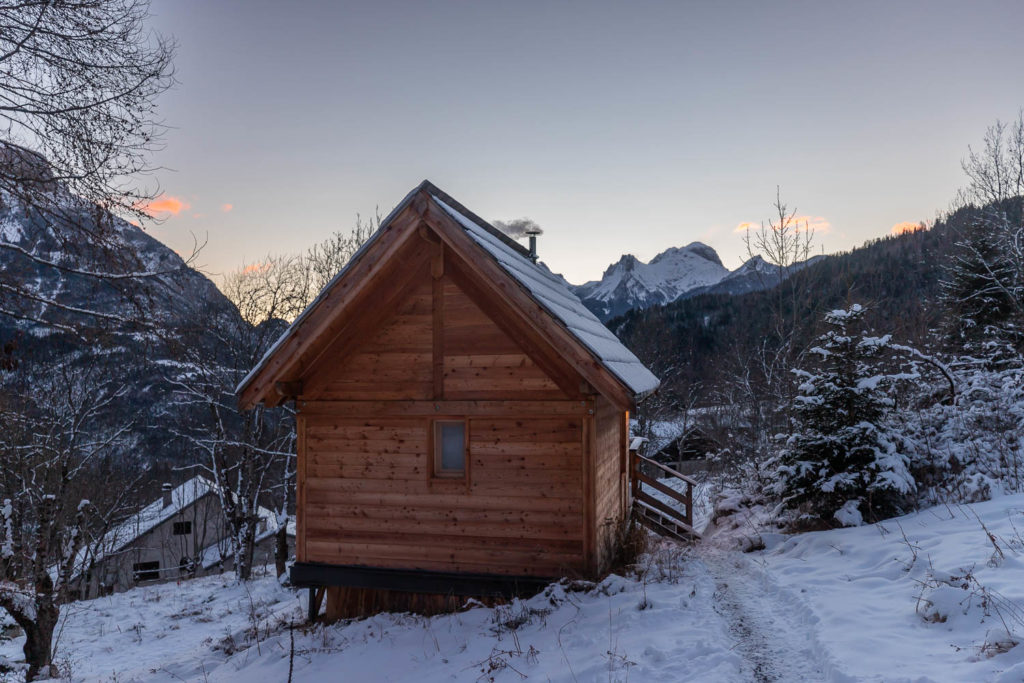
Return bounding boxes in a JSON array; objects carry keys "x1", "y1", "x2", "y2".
[{"x1": 770, "y1": 304, "x2": 915, "y2": 525}]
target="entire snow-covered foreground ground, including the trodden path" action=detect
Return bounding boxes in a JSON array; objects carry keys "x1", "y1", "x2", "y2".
[{"x1": 6, "y1": 496, "x2": 1024, "y2": 683}]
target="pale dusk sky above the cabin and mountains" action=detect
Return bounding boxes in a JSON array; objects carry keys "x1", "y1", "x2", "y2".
[{"x1": 147, "y1": 0, "x2": 1024, "y2": 283}]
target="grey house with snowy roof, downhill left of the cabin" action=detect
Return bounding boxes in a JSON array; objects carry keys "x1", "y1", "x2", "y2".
[{"x1": 78, "y1": 476, "x2": 295, "y2": 598}]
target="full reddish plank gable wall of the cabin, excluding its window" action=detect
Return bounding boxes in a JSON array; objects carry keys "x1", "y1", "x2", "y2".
[{"x1": 297, "y1": 257, "x2": 594, "y2": 577}]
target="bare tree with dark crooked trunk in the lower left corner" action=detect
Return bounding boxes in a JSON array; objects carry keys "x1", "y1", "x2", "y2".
[{"x1": 0, "y1": 364, "x2": 140, "y2": 681}]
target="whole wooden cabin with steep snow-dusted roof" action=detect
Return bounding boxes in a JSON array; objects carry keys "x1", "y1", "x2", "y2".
[{"x1": 238, "y1": 181, "x2": 658, "y2": 617}]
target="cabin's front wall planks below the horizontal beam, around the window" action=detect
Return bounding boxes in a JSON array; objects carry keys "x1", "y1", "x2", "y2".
[{"x1": 301, "y1": 414, "x2": 584, "y2": 575}]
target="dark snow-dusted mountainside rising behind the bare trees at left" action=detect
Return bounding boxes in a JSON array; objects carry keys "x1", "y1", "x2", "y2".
[{"x1": 0, "y1": 154, "x2": 241, "y2": 462}]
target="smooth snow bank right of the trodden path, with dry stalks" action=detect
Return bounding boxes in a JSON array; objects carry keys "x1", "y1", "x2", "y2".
[{"x1": 760, "y1": 495, "x2": 1024, "y2": 681}]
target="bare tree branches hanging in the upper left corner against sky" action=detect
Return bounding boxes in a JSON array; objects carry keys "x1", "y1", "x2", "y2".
[{"x1": 0, "y1": 0, "x2": 173, "y2": 331}]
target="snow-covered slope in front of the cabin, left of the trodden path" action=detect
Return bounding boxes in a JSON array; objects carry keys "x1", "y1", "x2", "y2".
[{"x1": 0, "y1": 557, "x2": 743, "y2": 683}]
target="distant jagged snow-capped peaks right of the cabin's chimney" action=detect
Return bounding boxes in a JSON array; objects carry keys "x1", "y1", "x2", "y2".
[{"x1": 573, "y1": 242, "x2": 729, "y2": 321}]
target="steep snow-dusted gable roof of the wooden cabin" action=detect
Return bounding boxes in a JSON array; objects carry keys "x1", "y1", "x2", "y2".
[{"x1": 236, "y1": 180, "x2": 660, "y2": 399}]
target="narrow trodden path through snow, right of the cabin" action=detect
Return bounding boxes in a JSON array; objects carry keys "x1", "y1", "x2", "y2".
[{"x1": 697, "y1": 546, "x2": 854, "y2": 683}]
